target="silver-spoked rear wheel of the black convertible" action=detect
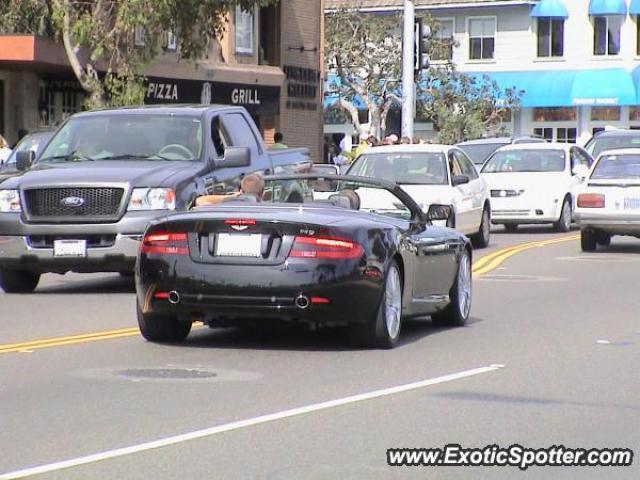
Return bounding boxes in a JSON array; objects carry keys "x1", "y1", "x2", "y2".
[{"x1": 351, "y1": 261, "x2": 402, "y2": 348}]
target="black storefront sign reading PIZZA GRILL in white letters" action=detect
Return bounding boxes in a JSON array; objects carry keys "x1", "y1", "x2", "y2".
[{"x1": 145, "y1": 77, "x2": 280, "y2": 115}]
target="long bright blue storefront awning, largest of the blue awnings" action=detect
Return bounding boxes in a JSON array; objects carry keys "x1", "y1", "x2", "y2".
[{"x1": 473, "y1": 68, "x2": 640, "y2": 108}]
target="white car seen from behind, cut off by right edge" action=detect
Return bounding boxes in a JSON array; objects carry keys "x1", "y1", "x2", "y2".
[{"x1": 575, "y1": 148, "x2": 640, "y2": 252}]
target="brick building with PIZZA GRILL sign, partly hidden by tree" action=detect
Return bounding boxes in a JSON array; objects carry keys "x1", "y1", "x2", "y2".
[{"x1": 0, "y1": 0, "x2": 323, "y2": 161}]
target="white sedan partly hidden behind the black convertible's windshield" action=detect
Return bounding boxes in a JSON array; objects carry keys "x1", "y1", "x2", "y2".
[{"x1": 347, "y1": 144, "x2": 491, "y2": 248}]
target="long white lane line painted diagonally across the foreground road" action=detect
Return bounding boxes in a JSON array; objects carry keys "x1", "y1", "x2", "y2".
[{"x1": 0, "y1": 364, "x2": 504, "y2": 480}]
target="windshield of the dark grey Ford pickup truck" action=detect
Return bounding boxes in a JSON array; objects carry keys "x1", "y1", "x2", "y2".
[{"x1": 39, "y1": 114, "x2": 202, "y2": 163}]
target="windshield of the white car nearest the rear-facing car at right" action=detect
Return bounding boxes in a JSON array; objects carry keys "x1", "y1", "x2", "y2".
[{"x1": 482, "y1": 149, "x2": 565, "y2": 173}]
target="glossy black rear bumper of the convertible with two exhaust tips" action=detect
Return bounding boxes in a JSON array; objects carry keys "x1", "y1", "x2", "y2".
[{"x1": 136, "y1": 255, "x2": 383, "y2": 325}]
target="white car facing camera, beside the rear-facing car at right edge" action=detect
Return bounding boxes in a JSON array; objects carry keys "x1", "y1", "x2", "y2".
[{"x1": 481, "y1": 143, "x2": 593, "y2": 232}]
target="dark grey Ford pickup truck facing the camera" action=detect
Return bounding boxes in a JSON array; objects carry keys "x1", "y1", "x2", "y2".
[{"x1": 0, "y1": 105, "x2": 311, "y2": 293}]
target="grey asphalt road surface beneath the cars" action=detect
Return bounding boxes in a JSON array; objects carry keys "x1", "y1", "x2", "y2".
[{"x1": 0, "y1": 227, "x2": 640, "y2": 480}]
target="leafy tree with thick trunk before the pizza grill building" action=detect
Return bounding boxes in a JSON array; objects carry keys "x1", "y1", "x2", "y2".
[{"x1": 0, "y1": 0, "x2": 278, "y2": 107}]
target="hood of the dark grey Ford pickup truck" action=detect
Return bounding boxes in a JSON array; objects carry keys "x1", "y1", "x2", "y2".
[{"x1": 2, "y1": 161, "x2": 200, "y2": 188}]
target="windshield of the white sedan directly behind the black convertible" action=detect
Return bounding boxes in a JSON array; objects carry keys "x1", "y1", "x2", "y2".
[{"x1": 348, "y1": 152, "x2": 447, "y2": 185}]
